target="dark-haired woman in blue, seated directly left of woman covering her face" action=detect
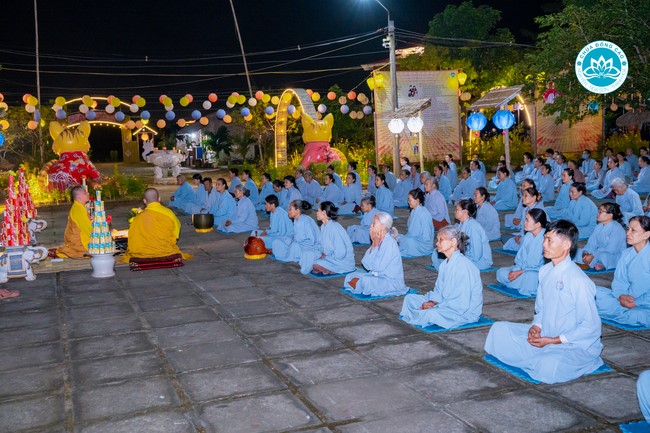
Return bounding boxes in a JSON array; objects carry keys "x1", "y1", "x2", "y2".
[{"x1": 312, "y1": 201, "x2": 356, "y2": 275}]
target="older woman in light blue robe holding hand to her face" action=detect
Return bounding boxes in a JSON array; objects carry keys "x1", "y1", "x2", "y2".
[{"x1": 344, "y1": 212, "x2": 409, "y2": 296}]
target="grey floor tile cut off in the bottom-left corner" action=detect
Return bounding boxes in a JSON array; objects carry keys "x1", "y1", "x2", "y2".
[{"x1": 0, "y1": 395, "x2": 64, "y2": 433}]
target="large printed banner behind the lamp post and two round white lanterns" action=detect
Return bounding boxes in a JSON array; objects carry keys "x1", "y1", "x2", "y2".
[{"x1": 374, "y1": 71, "x2": 460, "y2": 162}]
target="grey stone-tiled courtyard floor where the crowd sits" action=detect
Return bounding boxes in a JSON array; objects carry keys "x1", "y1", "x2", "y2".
[{"x1": 0, "y1": 206, "x2": 650, "y2": 433}]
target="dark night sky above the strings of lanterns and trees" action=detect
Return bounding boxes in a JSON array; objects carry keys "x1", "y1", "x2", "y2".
[{"x1": 0, "y1": 0, "x2": 560, "y2": 104}]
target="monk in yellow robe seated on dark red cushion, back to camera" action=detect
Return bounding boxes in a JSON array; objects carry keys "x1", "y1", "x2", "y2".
[{"x1": 122, "y1": 188, "x2": 192, "y2": 270}]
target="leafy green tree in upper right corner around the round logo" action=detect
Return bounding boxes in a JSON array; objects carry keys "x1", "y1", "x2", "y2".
[{"x1": 528, "y1": 0, "x2": 650, "y2": 122}]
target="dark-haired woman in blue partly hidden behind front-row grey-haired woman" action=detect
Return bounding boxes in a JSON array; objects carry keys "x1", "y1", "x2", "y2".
[{"x1": 431, "y1": 200, "x2": 492, "y2": 270}]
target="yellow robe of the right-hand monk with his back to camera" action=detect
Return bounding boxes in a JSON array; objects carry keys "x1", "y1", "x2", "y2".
[{"x1": 122, "y1": 202, "x2": 192, "y2": 262}]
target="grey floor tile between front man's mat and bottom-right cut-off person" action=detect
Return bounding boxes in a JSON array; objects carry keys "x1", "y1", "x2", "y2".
[{"x1": 549, "y1": 375, "x2": 643, "y2": 422}]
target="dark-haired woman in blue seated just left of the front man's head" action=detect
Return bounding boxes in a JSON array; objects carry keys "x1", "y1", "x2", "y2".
[{"x1": 497, "y1": 209, "x2": 548, "y2": 296}]
